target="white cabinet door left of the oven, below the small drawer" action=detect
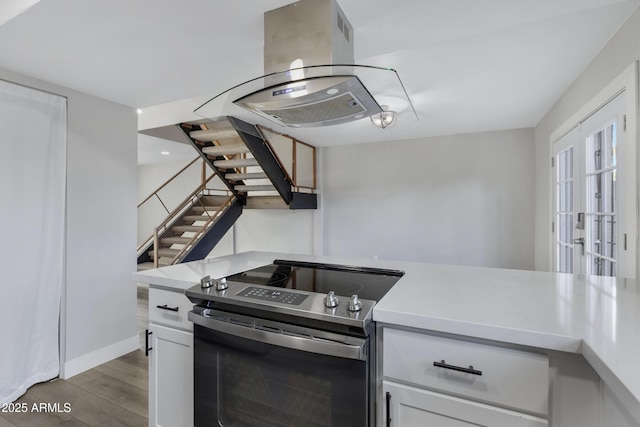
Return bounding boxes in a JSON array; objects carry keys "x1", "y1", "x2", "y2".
[{"x1": 149, "y1": 324, "x2": 193, "y2": 427}]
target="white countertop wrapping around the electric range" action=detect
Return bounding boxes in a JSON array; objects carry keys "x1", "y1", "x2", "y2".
[{"x1": 133, "y1": 252, "x2": 640, "y2": 419}]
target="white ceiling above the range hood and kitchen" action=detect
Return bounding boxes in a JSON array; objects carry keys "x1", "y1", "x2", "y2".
[{"x1": 0, "y1": 0, "x2": 640, "y2": 164}]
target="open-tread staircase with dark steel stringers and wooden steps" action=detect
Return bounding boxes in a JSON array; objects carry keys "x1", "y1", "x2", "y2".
[{"x1": 138, "y1": 117, "x2": 317, "y2": 270}]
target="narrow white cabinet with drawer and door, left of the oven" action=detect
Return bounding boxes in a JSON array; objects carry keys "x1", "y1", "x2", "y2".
[{"x1": 148, "y1": 288, "x2": 193, "y2": 427}]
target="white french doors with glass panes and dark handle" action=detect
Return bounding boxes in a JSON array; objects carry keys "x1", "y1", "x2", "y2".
[{"x1": 553, "y1": 92, "x2": 637, "y2": 277}]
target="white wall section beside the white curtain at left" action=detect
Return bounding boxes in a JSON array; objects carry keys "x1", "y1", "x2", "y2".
[{"x1": 0, "y1": 69, "x2": 139, "y2": 377}]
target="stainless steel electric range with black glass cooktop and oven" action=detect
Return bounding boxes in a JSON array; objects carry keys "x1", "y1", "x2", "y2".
[{"x1": 186, "y1": 260, "x2": 404, "y2": 427}]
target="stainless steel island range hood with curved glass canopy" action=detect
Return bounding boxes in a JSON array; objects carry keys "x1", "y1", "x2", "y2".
[{"x1": 195, "y1": 0, "x2": 415, "y2": 128}]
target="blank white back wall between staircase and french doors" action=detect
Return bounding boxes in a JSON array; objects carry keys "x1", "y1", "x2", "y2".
[{"x1": 322, "y1": 129, "x2": 534, "y2": 269}]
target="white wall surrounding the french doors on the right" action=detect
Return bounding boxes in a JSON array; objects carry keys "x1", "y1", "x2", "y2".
[{"x1": 535, "y1": 9, "x2": 640, "y2": 271}]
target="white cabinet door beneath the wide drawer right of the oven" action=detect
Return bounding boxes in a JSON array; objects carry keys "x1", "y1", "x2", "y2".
[{"x1": 382, "y1": 381, "x2": 548, "y2": 427}]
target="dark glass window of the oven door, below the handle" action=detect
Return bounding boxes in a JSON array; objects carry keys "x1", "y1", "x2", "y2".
[{"x1": 194, "y1": 325, "x2": 368, "y2": 427}]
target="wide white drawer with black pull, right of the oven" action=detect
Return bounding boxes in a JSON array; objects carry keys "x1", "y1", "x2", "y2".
[{"x1": 383, "y1": 328, "x2": 549, "y2": 417}]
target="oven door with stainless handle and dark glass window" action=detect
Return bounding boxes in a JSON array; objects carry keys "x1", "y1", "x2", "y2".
[{"x1": 189, "y1": 310, "x2": 370, "y2": 427}]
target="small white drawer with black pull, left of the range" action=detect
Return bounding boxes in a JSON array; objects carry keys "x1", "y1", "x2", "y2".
[{"x1": 149, "y1": 288, "x2": 193, "y2": 331}]
